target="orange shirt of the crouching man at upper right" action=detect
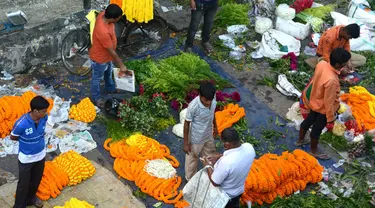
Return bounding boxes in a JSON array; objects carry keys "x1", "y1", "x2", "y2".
[{"x1": 316, "y1": 25, "x2": 350, "y2": 62}]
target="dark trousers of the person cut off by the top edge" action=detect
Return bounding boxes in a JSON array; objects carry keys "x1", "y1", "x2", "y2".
[{"x1": 185, "y1": 2, "x2": 218, "y2": 47}]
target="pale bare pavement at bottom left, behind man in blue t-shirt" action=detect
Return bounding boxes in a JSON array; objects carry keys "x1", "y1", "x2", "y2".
[{"x1": 0, "y1": 161, "x2": 145, "y2": 208}]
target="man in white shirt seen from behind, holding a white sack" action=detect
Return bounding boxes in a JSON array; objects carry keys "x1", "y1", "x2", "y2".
[{"x1": 204, "y1": 128, "x2": 255, "y2": 208}]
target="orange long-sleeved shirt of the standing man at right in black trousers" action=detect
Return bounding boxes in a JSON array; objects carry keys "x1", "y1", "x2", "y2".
[{"x1": 303, "y1": 61, "x2": 340, "y2": 122}]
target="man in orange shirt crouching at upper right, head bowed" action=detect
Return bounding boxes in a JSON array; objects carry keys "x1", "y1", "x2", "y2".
[{"x1": 306, "y1": 24, "x2": 366, "y2": 73}]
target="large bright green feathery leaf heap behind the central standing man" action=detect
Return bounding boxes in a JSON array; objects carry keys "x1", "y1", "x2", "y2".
[{"x1": 143, "y1": 53, "x2": 231, "y2": 101}]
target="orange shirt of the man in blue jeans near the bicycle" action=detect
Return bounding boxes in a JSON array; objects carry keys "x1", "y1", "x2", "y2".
[{"x1": 89, "y1": 12, "x2": 117, "y2": 64}]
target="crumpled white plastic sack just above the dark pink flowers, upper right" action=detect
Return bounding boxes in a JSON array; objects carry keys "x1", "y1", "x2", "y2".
[{"x1": 259, "y1": 29, "x2": 301, "y2": 59}]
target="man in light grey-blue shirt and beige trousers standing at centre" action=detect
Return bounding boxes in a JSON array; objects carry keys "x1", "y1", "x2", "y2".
[{"x1": 184, "y1": 82, "x2": 217, "y2": 181}]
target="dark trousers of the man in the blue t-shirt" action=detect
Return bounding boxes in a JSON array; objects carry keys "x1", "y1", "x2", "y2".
[{"x1": 14, "y1": 159, "x2": 45, "y2": 208}]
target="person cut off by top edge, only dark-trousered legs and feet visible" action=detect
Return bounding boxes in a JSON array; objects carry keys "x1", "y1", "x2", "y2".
[{"x1": 185, "y1": 0, "x2": 218, "y2": 53}]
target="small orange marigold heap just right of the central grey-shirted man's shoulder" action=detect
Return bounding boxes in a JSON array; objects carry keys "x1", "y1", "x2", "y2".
[{"x1": 215, "y1": 103, "x2": 246, "y2": 134}]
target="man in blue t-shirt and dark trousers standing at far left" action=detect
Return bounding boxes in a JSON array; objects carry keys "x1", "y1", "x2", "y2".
[{"x1": 10, "y1": 96, "x2": 49, "y2": 208}]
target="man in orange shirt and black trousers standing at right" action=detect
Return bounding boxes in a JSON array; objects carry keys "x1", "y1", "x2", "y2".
[{"x1": 295, "y1": 48, "x2": 351, "y2": 160}]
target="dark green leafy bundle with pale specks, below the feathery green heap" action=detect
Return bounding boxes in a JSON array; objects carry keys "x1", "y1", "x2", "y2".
[{"x1": 118, "y1": 94, "x2": 175, "y2": 136}]
